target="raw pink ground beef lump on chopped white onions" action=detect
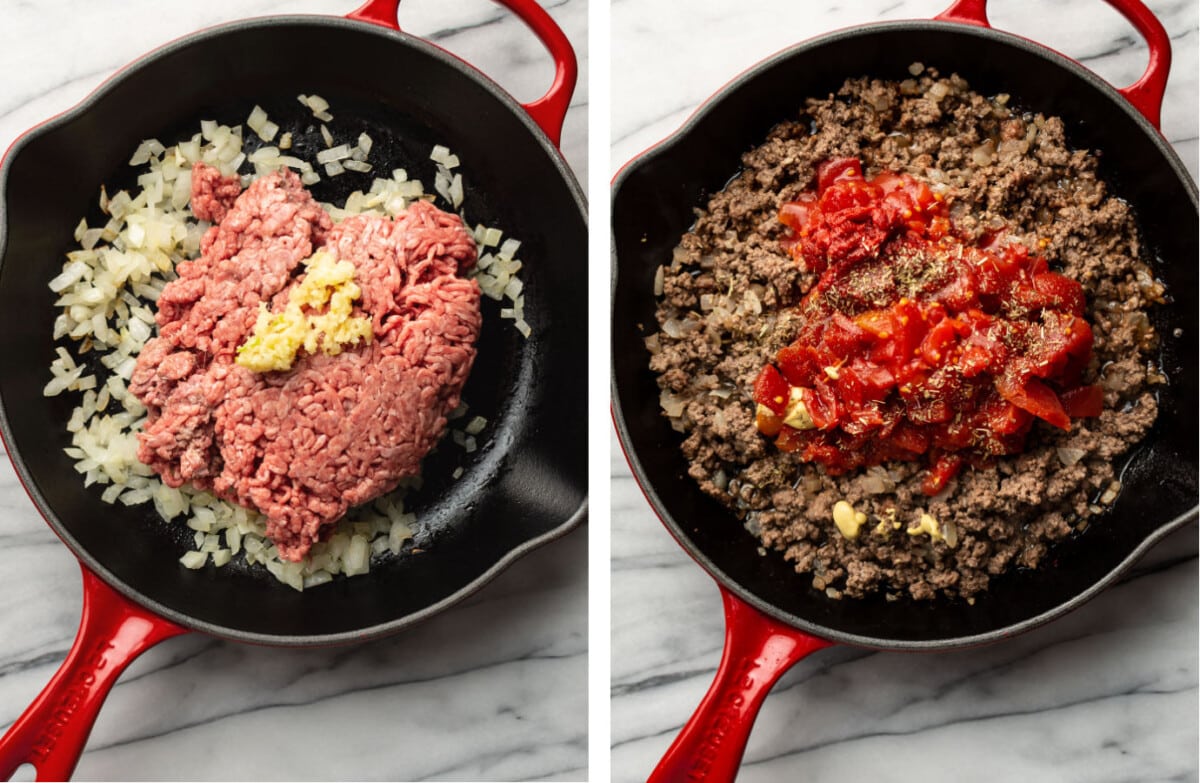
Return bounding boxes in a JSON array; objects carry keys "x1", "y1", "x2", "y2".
[{"x1": 130, "y1": 163, "x2": 481, "y2": 560}]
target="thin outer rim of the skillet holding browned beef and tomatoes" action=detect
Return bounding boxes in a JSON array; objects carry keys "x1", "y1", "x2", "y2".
[{"x1": 610, "y1": 19, "x2": 1200, "y2": 651}]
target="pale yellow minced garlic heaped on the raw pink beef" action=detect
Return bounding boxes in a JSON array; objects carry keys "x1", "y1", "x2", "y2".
[{"x1": 236, "y1": 251, "x2": 374, "y2": 372}]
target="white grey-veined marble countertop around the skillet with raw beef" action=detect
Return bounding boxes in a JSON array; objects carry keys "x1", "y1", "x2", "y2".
[{"x1": 0, "y1": 0, "x2": 588, "y2": 781}]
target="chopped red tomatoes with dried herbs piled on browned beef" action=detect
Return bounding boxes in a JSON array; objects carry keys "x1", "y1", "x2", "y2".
[{"x1": 754, "y1": 159, "x2": 1103, "y2": 495}]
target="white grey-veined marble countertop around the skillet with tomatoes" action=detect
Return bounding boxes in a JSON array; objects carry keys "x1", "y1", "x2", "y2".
[{"x1": 611, "y1": 0, "x2": 1200, "y2": 783}]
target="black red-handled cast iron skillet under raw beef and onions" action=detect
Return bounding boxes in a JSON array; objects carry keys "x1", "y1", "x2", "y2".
[{"x1": 0, "y1": 0, "x2": 587, "y2": 779}]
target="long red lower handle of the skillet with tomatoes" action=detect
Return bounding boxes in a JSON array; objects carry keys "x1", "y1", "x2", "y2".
[{"x1": 648, "y1": 587, "x2": 833, "y2": 783}]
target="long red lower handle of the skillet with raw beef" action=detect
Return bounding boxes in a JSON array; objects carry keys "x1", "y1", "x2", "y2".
[{"x1": 0, "y1": 568, "x2": 186, "y2": 781}]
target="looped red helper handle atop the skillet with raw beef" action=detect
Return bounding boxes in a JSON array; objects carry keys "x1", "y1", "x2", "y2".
[{"x1": 346, "y1": 0, "x2": 578, "y2": 147}]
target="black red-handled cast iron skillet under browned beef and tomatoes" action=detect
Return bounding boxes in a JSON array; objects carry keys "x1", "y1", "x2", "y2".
[{"x1": 612, "y1": 0, "x2": 1198, "y2": 781}]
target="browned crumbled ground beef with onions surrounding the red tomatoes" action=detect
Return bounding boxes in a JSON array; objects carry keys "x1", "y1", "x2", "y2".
[{"x1": 647, "y1": 70, "x2": 1164, "y2": 600}]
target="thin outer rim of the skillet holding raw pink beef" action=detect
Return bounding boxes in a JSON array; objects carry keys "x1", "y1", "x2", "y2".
[{"x1": 0, "y1": 14, "x2": 588, "y2": 647}]
